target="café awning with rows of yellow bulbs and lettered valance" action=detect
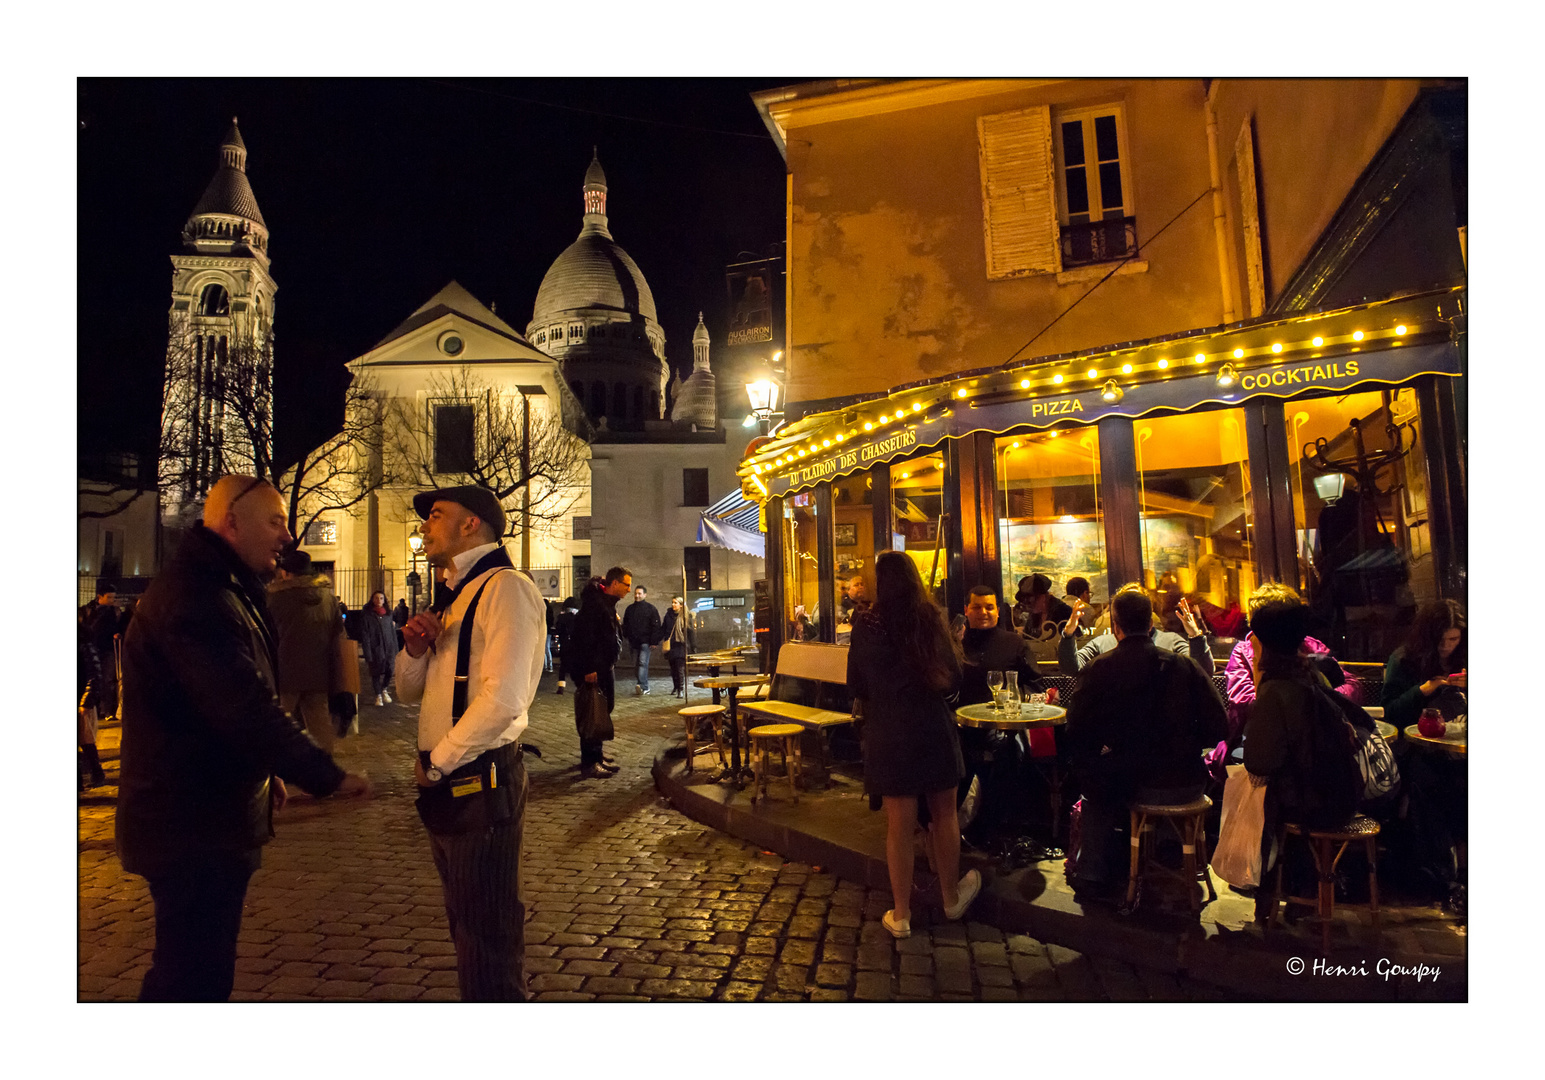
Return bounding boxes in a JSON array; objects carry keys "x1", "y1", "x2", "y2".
[{"x1": 740, "y1": 287, "x2": 1465, "y2": 501}]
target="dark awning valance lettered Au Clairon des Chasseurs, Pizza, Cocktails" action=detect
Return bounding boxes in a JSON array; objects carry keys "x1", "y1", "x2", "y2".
[{"x1": 762, "y1": 343, "x2": 1460, "y2": 496}]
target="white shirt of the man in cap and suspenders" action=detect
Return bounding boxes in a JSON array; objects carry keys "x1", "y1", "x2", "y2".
[{"x1": 397, "y1": 544, "x2": 547, "y2": 773}]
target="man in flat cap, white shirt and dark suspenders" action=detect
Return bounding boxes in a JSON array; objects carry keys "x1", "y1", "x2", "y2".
[{"x1": 397, "y1": 485, "x2": 547, "y2": 1001}]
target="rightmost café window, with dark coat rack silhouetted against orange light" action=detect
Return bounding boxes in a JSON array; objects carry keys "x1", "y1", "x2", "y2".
[{"x1": 1282, "y1": 388, "x2": 1437, "y2": 663}]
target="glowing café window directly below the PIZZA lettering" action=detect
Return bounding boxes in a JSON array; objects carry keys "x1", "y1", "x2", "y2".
[{"x1": 987, "y1": 428, "x2": 1106, "y2": 644}]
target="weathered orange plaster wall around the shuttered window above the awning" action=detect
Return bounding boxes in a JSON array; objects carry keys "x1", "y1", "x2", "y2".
[{"x1": 786, "y1": 79, "x2": 1222, "y2": 403}]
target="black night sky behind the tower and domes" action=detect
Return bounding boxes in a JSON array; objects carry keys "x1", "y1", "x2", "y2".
[{"x1": 77, "y1": 77, "x2": 799, "y2": 464}]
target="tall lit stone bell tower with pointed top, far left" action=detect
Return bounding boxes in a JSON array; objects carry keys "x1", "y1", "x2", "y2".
[{"x1": 159, "y1": 117, "x2": 277, "y2": 528}]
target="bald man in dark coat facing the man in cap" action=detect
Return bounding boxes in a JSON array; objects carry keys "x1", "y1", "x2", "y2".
[{"x1": 116, "y1": 476, "x2": 369, "y2": 1001}]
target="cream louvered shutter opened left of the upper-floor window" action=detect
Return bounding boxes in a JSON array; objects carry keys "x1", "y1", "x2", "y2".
[{"x1": 976, "y1": 105, "x2": 1061, "y2": 278}]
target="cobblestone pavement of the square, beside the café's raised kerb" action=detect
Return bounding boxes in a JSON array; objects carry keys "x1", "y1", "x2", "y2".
[{"x1": 77, "y1": 677, "x2": 1236, "y2": 1001}]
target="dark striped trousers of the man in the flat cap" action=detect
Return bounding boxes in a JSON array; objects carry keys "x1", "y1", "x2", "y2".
[{"x1": 430, "y1": 763, "x2": 527, "y2": 1001}]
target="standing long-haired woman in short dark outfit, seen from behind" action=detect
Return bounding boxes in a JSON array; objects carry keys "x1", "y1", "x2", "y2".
[{"x1": 848, "y1": 552, "x2": 981, "y2": 938}]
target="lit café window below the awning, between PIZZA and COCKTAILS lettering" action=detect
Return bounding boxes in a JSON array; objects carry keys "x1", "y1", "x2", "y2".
[{"x1": 1132, "y1": 409, "x2": 1256, "y2": 637}]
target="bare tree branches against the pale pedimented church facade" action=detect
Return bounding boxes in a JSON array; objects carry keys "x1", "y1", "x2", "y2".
[{"x1": 386, "y1": 366, "x2": 589, "y2": 536}]
